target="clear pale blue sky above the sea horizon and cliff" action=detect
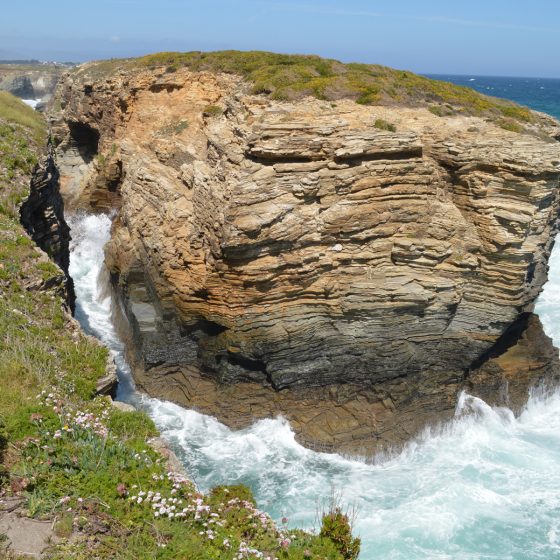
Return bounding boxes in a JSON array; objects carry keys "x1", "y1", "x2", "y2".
[{"x1": 0, "y1": 0, "x2": 560, "y2": 78}]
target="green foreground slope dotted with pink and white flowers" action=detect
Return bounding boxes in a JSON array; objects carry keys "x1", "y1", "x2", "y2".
[{"x1": 0, "y1": 94, "x2": 359, "y2": 560}]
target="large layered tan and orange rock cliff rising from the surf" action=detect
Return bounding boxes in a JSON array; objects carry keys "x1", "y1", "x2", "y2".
[{"x1": 53, "y1": 63, "x2": 560, "y2": 451}]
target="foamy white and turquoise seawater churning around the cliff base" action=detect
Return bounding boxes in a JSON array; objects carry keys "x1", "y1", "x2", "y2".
[{"x1": 69, "y1": 211, "x2": 560, "y2": 560}]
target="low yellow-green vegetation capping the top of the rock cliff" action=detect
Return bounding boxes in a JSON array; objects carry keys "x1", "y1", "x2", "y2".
[{"x1": 80, "y1": 51, "x2": 532, "y2": 126}]
